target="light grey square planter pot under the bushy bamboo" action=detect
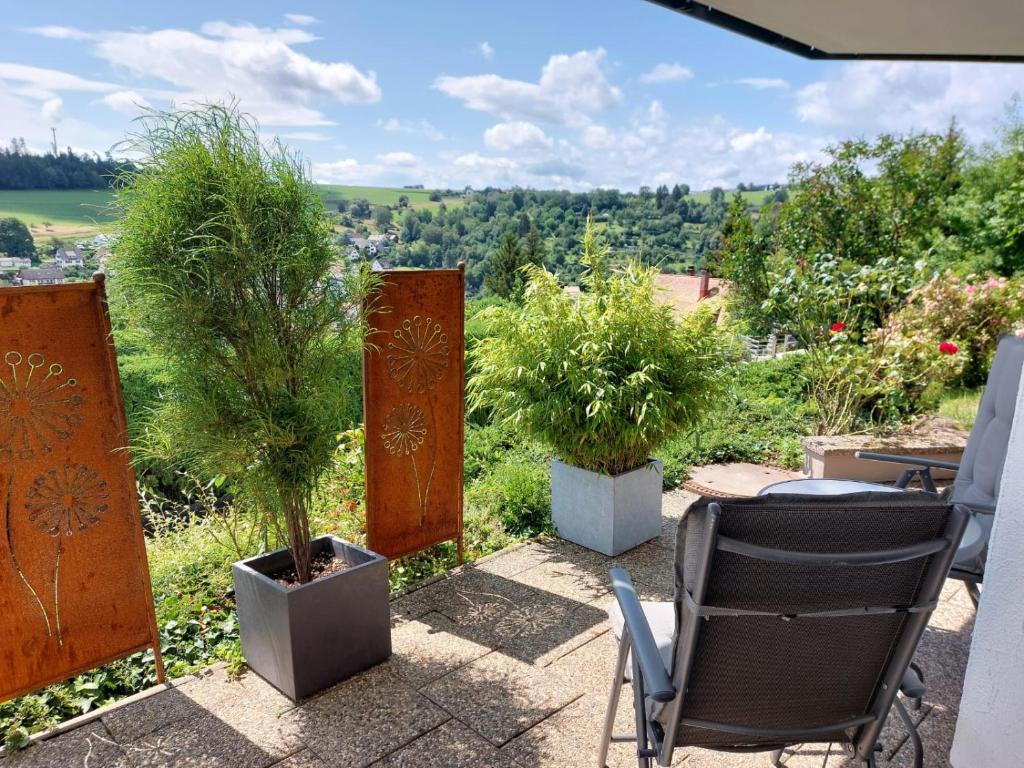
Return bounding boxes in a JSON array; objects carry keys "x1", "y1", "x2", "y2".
[{"x1": 551, "y1": 459, "x2": 662, "y2": 555}]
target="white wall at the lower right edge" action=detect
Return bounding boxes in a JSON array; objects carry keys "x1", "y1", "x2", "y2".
[{"x1": 950, "y1": 370, "x2": 1024, "y2": 768}]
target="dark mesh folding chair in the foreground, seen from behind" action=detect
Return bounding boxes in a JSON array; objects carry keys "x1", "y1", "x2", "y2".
[{"x1": 598, "y1": 493, "x2": 969, "y2": 768}]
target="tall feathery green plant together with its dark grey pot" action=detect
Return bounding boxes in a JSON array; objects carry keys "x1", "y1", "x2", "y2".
[{"x1": 112, "y1": 104, "x2": 391, "y2": 699}]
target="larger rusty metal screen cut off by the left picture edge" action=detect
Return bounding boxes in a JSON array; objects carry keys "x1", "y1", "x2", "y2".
[{"x1": 0, "y1": 275, "x2": 163, "y2": 701}]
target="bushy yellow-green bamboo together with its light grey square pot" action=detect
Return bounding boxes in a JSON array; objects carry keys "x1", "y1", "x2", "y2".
[{"x1": 468, "y1": 221, "x2": 728, "y2": 555}]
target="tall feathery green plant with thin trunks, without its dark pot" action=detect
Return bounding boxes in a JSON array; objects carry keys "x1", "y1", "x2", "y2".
[{"x1": 115, "y1": 104, "x2": 379, "y2": 583}]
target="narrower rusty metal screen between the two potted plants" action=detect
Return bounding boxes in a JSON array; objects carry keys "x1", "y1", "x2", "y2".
[{"x1": 362, "y1": 265, "x2": 465, "y2": 560}]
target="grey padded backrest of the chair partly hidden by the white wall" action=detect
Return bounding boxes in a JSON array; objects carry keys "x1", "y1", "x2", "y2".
[{"x1": 950, "y1": 335, "x2": 1024, "y2": 507}]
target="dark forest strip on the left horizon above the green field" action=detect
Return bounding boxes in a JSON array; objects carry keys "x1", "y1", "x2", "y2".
[{"x1": 0, "y1": 138, "x2": 133, "y2": 189}]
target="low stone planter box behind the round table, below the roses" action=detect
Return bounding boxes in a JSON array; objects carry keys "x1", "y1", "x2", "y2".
[{"x1": 802, "y1": 419, "x2": 968, "y2": 482}]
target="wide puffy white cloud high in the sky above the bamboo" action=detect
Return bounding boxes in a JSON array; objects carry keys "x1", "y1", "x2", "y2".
[{"x1": 434, "y1": 48, "x2": 623, "y2": 124}]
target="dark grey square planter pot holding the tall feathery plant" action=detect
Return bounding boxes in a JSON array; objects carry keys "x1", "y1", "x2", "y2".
[{"x1": 231, "y1": 536, "x2": 391, "y2": 701}]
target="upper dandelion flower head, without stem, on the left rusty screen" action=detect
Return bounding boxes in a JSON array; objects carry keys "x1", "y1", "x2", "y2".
[{"x1": 0, "y1": 351, "x2": 85, "y2": 460}]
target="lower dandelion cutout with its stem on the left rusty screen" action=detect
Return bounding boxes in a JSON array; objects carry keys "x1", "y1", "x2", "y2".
[{"x1": 23, "y1": 464, "x2": 110, "y2": 645}]
